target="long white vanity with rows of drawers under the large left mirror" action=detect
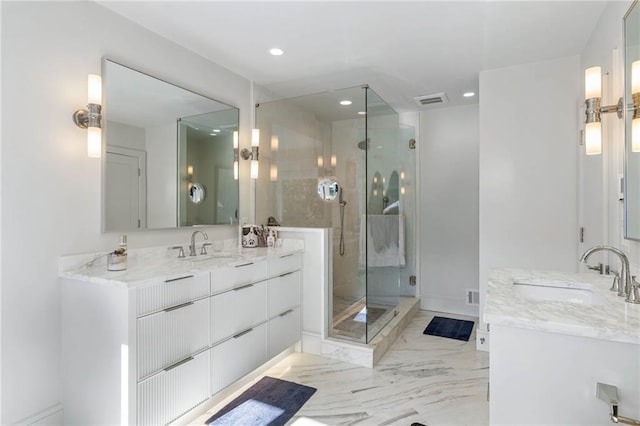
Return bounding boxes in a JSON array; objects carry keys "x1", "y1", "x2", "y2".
[{"x1": 61, "y1": 242, "x2": 303, "y2": 425}]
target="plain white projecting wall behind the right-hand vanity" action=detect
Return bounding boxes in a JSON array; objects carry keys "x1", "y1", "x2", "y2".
[{"x1": 479, "y1": 56, "x2": 581, "y2": 336}]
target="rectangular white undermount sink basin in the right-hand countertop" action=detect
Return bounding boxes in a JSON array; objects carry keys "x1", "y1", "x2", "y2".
[{"x1": 513, "y1": 280, "x2": 607, "y2": 305}]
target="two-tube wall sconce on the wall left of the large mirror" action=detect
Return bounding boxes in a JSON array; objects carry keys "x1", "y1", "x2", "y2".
[{"x1": 73, "y1": 74, "x2": 102, "y2": 158}]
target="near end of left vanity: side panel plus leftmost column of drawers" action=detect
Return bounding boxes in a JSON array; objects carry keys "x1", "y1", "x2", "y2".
[{"x1": 62, "y1": 273, "x2": 210, "y2": 425}]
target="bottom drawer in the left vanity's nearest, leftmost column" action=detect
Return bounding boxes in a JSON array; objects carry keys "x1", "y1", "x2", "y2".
[{"x1": 137, "y1": 350, "x2": 211, "y2": 425}]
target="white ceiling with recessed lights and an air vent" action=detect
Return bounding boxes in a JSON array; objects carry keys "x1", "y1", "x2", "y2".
[{"x1": 99, "y1": 0, "x2": 606, "y2": 112}]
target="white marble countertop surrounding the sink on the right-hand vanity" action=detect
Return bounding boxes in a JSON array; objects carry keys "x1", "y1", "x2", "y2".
[{"x1": 483, "y1": 269, "x2": 640, "y2": 344}]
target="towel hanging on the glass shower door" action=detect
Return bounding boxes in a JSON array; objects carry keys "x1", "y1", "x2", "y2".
[{"x1": 360, "y1": 214, "x2": 406, "y2": 266}]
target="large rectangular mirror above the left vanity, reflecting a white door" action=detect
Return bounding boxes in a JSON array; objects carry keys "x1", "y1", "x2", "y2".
[{"x1": 102, "y1": 59, "x2": 238, "y2": 232}]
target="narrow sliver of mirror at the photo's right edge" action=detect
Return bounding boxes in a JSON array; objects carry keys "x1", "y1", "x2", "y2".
[{"x1": 624, "y1": 1, "x2": 640, "y2": 240}]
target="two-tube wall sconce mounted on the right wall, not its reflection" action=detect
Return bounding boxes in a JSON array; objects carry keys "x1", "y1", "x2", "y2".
[{"x1": 584, "y1": 67, "x2": 624, "y2": 155}]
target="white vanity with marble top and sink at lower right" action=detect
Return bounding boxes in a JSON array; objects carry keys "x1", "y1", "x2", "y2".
[{"x1": 484, "y1": 269, "x2": 640, "y2": 425}]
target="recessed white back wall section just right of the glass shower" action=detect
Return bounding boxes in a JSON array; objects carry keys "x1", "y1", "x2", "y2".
[{"x1": 419, "y1": 105, "x2": 479, "y2": 316}]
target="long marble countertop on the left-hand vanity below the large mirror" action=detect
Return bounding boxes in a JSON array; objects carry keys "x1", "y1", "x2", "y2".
[{"x1": 58, "y1": 240, "x2": 304, "y2": 287}]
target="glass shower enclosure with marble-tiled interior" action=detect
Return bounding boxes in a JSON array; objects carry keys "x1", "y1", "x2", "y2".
[{"x1": 256, "y1": 85, "x2": 416, "y2": 343}]
